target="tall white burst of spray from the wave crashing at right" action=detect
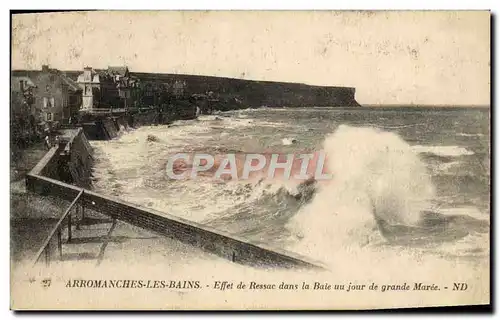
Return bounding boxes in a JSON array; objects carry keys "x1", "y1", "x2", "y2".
[{"x1": 288, "y1": 125, "x2": 434, "y2": 258}]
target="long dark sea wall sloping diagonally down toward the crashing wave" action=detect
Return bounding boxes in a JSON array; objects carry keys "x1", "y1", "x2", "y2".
[{"x1": 26, "y1": 173, "x2": 324, "y2": 269}]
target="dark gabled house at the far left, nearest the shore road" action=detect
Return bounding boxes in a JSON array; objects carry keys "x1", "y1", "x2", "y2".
[{"x1": 11, "y1": 65, "x2": 82, "y2": 127}]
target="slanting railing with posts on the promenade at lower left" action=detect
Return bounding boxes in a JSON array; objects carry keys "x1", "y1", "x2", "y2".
[{"x1": 32, "y1": 189, "x2": 84, "y2": 266}]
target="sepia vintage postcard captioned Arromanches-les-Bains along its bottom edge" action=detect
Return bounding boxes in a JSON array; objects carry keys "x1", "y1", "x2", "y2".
[{"x1": 10, "y1": 11, "x2": 491, "y2": 310}]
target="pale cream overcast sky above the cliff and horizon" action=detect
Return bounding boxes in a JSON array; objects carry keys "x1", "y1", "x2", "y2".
[{"x1": 12, "y1": 11, "x2": 490, "y2": 105}]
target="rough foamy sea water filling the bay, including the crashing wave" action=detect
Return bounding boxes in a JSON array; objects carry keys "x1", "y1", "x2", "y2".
[{"x1": 92, "y1": 107, "x2": 490, "y2": 278}]
